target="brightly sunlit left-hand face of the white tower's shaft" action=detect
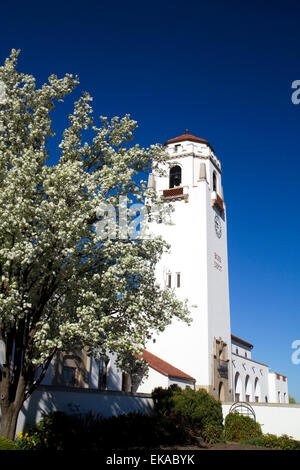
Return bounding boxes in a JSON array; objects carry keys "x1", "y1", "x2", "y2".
[{"x1": 147, "y1": 176, "x2": 209, "y2": 384}]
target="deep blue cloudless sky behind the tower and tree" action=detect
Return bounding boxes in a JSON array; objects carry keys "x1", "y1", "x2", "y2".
[{"x1": 0, "y1": 0, "x2": 300, "y2": 402}]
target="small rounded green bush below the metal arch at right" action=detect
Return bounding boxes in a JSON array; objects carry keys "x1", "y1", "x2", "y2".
[{"x1": 225, "y1": 412, "x2": 262, "y2": 442}]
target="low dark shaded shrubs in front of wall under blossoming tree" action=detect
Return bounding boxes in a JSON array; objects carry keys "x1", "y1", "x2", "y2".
[{"x1": 17, "y1": 411, "x2": 189, "y2": 451}]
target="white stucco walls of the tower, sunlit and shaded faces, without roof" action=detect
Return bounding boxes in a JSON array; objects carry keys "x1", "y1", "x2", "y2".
[{"x1": 147, "y1": 142, "x2": 231, "y2": 392}]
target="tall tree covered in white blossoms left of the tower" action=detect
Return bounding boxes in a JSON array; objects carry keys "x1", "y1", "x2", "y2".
[{"x1": 0, "y1": 50, "x2": 188, "y2": 439}]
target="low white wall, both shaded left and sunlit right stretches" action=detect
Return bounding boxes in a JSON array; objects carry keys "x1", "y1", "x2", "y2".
[{"x1": 7, "y1": 386, "x2": 300, "y2": 440}]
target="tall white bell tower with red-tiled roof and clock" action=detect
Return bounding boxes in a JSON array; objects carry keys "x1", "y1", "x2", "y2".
[{"x1": 147, "y1": 131, "x2": 232, "y2": 400}]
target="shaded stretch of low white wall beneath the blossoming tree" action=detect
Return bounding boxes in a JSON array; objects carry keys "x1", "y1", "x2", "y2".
[{"x1": 17, "y1": 386, "x2": 153, "y2": 433}]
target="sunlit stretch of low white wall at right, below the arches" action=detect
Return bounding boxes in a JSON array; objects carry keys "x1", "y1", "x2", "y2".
[{"x1": 222, "y1": 403, "x2": 300, "y2": 440}]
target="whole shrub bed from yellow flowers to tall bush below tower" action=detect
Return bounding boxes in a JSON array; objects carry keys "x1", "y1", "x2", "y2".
[{"x1": 17, "y1": 385, "x2": 223, "y2": 451}]
